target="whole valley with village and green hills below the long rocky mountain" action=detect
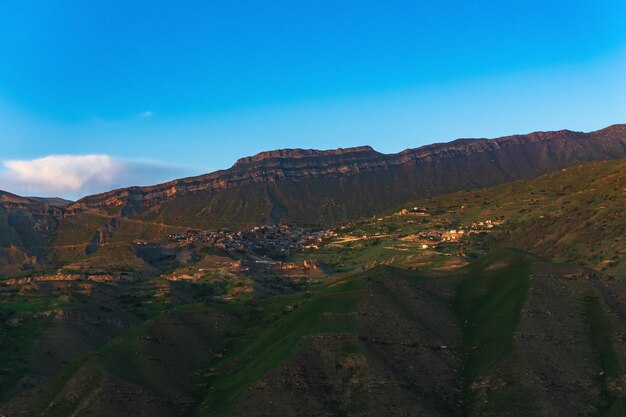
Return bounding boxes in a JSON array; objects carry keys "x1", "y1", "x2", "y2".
[{"x1": 0, "y1": 128, "x2": 626, "y2": 417}]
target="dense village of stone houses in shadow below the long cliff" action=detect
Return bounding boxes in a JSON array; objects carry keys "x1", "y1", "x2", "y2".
[{"x1": 163, "y1": 225, "x2": 336, "y2": 258}]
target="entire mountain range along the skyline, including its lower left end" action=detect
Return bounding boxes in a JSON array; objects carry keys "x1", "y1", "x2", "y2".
[{"x1": 0, "y1": 125, "x2": 626, "y2": 275}]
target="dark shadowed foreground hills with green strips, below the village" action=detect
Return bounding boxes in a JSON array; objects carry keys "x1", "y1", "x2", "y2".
[{"x1": 0, "y1": 251, "x2": 626, "y2": 417}]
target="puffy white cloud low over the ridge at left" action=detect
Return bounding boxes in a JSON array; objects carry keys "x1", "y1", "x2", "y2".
[{"x1": 0, "y1": 155, "x2": 184, "y2": 199}]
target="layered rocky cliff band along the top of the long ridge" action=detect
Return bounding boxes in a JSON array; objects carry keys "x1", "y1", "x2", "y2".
[{"x1": 68, "y1": 125, "x2": 626, "y2": 212}]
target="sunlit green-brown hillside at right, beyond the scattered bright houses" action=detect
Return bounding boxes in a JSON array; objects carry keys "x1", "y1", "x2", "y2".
[{"x1": 390, "y1": 159, "x2": 626, "y2": 278}]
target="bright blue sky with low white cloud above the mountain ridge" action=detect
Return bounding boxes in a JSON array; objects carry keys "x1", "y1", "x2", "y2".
[{"x1": 0, "y1": 0, "x2": 626, "y2": 198}]
